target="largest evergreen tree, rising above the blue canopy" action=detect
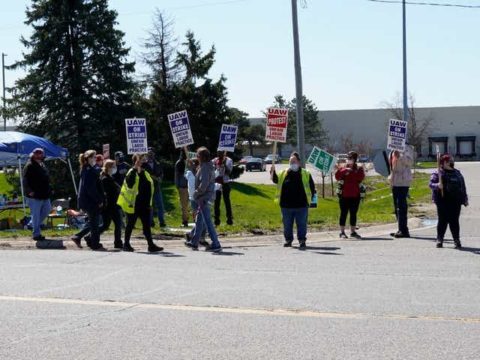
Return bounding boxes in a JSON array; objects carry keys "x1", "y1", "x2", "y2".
[{"x1": 10, "y1": 0, "x2": 135, "y2": 154}]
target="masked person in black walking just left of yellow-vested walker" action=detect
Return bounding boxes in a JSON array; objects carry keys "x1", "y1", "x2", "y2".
[{"x1": 100, "y1": 160, "x2": 123, "y2": 249}]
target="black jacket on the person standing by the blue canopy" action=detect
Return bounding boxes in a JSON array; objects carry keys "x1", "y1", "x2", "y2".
[{"x1": 23, "y1": 160, "x2": 52, "y2": 200}]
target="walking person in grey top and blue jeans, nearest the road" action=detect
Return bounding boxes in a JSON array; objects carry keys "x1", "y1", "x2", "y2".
[{"x1": 185, "y1": 147, "x2": 222, "y2": 252}]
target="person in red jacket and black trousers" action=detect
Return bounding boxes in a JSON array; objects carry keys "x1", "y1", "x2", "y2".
[{"x1": 335, "y1": 151, "x2": 365, "y2": 239}]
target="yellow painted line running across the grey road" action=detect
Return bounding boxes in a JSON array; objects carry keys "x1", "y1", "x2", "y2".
[{"x1": 0, "y1": 295, "x2": 480, "y2": 324}]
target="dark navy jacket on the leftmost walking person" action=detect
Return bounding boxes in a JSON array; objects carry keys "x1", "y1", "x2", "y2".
[{"x1": 78, "y1": 165, "x2": 105, "y2": 211}]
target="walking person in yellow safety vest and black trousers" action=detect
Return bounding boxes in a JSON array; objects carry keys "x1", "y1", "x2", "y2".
[{"x1": 117, "y1": 154, "x2": 163, "y2": 253}]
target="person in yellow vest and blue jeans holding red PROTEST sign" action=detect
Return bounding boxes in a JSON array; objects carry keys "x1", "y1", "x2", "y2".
[{"x1": 270, "y1": 152, "x2": 317, "y2": 249}]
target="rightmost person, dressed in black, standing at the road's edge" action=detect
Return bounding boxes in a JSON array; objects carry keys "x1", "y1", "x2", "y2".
[{"x1": 430, "y1": 154, "x2": 468, "y2": 249}]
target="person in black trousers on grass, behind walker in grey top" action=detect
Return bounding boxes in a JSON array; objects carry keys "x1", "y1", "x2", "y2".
[{"x1": 213, "y1": 151, "x2": 233, "y2": 226}]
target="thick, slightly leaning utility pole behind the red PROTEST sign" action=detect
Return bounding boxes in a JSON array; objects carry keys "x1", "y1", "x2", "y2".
[{"x1": 292, "y1": 0, "x2": 305, "y2": 164}]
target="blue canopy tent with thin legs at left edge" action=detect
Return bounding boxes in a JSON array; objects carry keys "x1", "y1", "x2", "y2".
[{"x1": 0, "y1": 131, "x2": 77, "y2": 217}]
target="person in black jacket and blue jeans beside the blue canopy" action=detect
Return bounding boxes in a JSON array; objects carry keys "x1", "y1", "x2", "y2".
[{"x1": 23, "y1": 148, "x2": 52, "y2": 241}]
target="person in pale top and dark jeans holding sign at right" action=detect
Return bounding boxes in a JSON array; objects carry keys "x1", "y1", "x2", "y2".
[{"x1": 389, "y1": 145, "x2": 414, "y2": 238}]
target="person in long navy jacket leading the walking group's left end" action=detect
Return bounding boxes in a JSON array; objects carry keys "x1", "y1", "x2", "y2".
[{"x1": 72, "y1": 150, "x2": 105, "y2": 251}]
